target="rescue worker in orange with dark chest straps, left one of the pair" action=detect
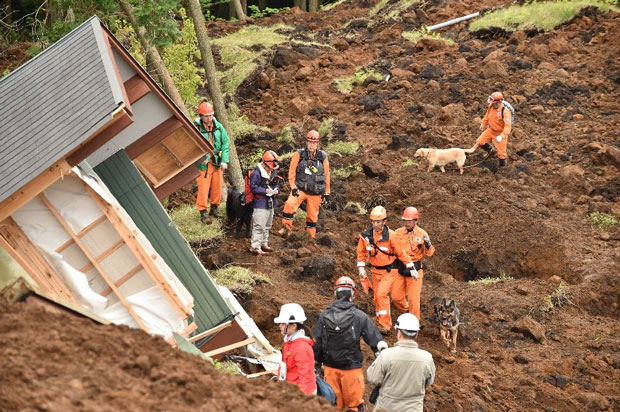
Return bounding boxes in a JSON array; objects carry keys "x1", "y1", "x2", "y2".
[{"x1": 357, "y1": 206, "x2": 414, "y2": 334}]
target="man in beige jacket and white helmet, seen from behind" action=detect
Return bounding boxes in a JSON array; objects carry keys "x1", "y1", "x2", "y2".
[{"x1": 366, "y1": 313, "x2": 435, "y2": 412}]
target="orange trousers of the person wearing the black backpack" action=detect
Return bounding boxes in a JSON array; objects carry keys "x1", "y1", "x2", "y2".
[{"x1": 323, "y1": 366, "x2": 364, "y2": 411}]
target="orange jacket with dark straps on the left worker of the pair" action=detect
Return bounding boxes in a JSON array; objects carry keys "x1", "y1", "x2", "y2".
[{"x1": 357, "y1": 226, "x2": 411, "y2": 267}]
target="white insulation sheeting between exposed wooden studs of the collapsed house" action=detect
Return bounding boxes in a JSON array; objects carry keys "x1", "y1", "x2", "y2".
[{"x1": 12, "y1": 167, "x2": 193, "y2": 337}]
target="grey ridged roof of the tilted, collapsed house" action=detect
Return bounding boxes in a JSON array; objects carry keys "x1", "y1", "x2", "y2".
[{"x1": 0, "y1": 16, "x2": 122, "y2": 202}]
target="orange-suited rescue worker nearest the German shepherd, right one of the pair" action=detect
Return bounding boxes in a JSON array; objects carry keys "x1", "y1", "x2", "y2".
[{"x1": 392, "y1": 206, "x2": 435, "y2": 319}]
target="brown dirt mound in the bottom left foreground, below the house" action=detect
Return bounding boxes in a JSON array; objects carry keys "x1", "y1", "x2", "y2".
[{"x1": 0, "y1": 303, "x2": 331, "y2": 411}]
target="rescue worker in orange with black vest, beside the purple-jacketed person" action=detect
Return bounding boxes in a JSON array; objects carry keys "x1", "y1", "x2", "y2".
[{"x1": 278, "y1": 130, "x2": 330, "y2": 238}]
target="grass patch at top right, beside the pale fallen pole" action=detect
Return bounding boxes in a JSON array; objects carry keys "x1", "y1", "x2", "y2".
[{"x1": 469, "y1": 0, "x2": 618, "y2": 32}]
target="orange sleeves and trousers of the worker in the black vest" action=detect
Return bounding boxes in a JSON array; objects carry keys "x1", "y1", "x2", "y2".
[{"x1": 282, "y1": 149, "x2": 330, "y2": 237}]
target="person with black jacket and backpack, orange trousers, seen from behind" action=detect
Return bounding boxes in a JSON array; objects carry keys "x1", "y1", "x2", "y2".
[{"x1": 312, "y1": 276, "x2": 387, "y2": 412}]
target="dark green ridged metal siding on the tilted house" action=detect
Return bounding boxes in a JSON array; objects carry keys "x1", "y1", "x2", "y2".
[{"x1": 95, "y1": 150, "x2": 231, "y2": 333}]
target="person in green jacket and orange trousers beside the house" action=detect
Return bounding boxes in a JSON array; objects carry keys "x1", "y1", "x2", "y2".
[{"x1": 194, "y1": 102, "x2": 229, "y2": 224}]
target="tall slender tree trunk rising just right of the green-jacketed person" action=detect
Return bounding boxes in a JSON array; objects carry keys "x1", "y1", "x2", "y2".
[{"x1": 187, "y1": 0, "x2": 245, "y2": 193}]
